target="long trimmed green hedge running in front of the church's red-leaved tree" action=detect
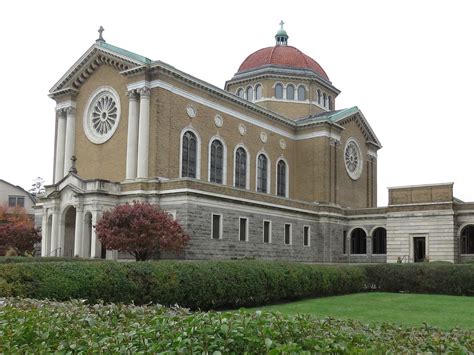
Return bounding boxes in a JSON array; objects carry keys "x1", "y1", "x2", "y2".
[{"x1": 0, "y1": 260, "x2": 366, "y2": 310}]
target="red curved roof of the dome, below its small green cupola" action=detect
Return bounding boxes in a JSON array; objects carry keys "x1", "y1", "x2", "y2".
[{"x1": 238, "y1": 45, "x2": 329, "y2": 81}]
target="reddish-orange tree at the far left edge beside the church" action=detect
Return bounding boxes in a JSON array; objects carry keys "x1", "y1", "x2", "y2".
[{"x1": 0, "y1": 206, "x2": 41, "y2": 255}]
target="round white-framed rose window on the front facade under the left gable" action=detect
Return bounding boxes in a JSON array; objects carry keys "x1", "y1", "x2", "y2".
[{"x1": 84, "y1": 87, "x2": 120, "y2": 144}]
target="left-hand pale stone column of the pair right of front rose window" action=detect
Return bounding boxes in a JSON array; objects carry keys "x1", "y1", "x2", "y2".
[{"x1": 125, "y1": 90, "x2": 138, "y2": 180}]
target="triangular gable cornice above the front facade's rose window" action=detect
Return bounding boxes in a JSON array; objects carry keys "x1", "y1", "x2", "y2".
[{"x1": 49, "y1": 41, "x2": 151, "y2": 97}]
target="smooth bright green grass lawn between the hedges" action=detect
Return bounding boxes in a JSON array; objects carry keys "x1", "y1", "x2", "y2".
[{"x1": 257, "y1": 292, "x2": 474, "y2": 329}]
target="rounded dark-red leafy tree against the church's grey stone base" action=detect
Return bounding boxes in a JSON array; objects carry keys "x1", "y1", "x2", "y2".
[{"x1": 95, "y1": 201, "x2": 189, "y2": 261}]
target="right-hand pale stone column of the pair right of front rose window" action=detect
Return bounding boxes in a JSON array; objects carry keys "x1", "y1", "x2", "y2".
[{"x1": 137, "y1": 88, "x2": 150, "y2": 179}]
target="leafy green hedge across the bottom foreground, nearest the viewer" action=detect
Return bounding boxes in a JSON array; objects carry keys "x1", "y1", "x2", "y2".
[{"x1": 0, "y1": 299, "x2": 474, "y2": 354}]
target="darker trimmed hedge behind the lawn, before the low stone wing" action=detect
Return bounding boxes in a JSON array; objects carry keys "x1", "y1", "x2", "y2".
[{"x1": 365, "y1": 262, "x2": 474, "y2": 296}]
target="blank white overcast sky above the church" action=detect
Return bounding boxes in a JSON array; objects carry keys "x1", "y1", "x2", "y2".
[{"x1": 0, "y1": 0, "x2": 474, "y2": 206}]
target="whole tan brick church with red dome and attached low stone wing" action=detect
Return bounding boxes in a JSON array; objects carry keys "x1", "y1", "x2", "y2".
[{"x1": 37, "y1": 25, "x2": 474, "y2": 263}]
